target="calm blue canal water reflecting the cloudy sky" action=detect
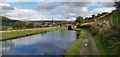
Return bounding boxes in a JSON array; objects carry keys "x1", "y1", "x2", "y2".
[{"x1": 2, "y1": 30, "x2": 76, "y2": 55}]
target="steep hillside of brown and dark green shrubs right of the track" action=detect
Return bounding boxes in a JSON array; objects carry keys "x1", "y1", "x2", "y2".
[{"x1": 84, "y1": 10, "x2": 120, "y2": 55}]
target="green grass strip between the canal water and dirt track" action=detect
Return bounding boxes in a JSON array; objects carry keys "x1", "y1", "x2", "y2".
[{"x1": 65, "y1": 30, "x2": 85, "y2": 57}]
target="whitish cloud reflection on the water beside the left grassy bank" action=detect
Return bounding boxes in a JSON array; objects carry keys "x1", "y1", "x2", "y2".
[{"x1": 7, "y1": 34, "x2": 42, "y2": 46}]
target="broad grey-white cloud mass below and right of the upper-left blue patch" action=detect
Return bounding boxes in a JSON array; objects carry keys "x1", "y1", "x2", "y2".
[{"x1": 0, "y1": 2, "x2": 115, "y2": 21}]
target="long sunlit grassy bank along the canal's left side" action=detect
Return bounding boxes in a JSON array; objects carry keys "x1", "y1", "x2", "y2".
[{"x1": 0, "y1": 27, "x2": 65, "y2": 40}]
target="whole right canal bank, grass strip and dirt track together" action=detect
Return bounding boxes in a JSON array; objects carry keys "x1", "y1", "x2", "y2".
[{"x1": 64, "y1": 30, "x2": 100, "y2": 57}]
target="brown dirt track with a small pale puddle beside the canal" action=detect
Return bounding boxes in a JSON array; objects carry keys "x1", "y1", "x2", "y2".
[{"x1": 80, "y1": 32, "x2": 99, "y2": 55}]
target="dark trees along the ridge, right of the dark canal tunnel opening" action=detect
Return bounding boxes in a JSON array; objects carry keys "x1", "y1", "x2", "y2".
[{"x1": 75, "y1": 12, "x2": 110, "y2": 28}]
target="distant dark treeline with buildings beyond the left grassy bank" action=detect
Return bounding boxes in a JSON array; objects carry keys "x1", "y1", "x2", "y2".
[{"x1": 0, "y1": 16, "x2": 74, "y2": 30}]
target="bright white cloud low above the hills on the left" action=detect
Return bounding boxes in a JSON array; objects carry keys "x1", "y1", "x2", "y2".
[{"x1": 2, "y1": 9, "x2": 47, "y2": 20}]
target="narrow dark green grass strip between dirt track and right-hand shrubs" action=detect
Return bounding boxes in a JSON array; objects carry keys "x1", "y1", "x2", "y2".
[{"x1": 93, "y1": 36, "x2": 107, "y2": 55}]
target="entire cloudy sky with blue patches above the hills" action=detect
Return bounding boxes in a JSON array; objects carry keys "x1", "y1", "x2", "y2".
[{"x1": 0, "y1": 0, "x2": 118, "y2": 21}]
